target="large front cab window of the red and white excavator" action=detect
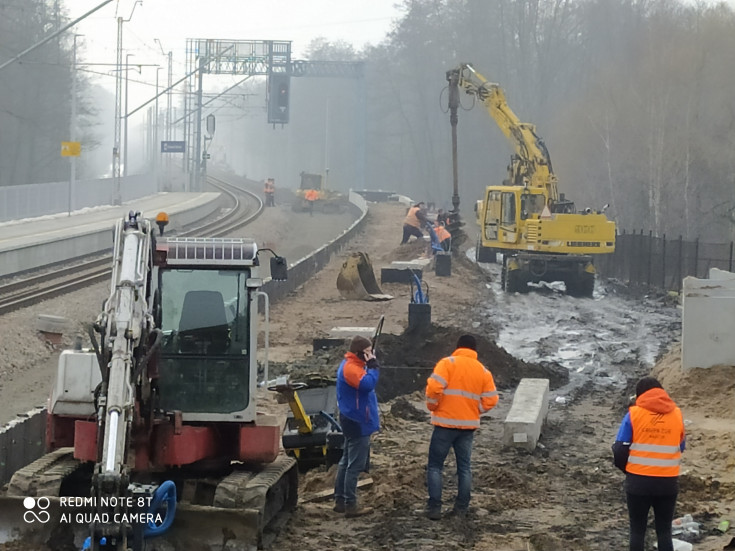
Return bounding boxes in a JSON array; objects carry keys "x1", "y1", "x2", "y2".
[{"x1": 158, "y1": 269, "x2": 250, "y2": 413}]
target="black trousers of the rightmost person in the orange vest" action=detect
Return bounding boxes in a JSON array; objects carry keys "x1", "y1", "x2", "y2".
[{"x1": 627, "y1": 493, "x2": 676, "y2": 551}]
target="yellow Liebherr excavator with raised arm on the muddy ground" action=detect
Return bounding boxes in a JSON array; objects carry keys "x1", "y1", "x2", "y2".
[{"x1": 447, "y1": 63, "x2": 615, "y2": 297}]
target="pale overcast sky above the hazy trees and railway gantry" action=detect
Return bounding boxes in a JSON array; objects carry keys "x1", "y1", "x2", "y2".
[{"x1": 70, "y1": 0, "x2": 400, "y2": 96}]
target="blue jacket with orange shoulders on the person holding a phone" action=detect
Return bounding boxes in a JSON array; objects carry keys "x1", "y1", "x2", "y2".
[{"x1": 337, "y1": 352, "x2": 380, "y2": 436}]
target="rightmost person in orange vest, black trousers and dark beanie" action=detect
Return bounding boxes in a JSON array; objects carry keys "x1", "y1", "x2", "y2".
[{"x1": 613, "y1": 377, "x2": 686, "y2": 551}]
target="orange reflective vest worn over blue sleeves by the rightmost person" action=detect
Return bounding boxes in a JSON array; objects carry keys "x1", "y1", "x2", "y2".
[{"x1": 625, "y1": 388, "x2": 684, "y2": 476}]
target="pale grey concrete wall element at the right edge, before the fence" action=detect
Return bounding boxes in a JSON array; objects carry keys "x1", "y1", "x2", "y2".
[{"x1": 681, "y1": 268, "x2": 735, "y2": 369}]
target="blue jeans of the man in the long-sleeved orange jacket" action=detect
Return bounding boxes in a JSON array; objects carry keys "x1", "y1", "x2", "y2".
[{"x1": 426, "y1": 425, "x2": 475, "y2": 510}]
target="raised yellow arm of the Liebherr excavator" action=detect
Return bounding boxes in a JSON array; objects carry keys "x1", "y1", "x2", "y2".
[{"x1": 447, "y1": 63, "x2": 559, "y2": 203}]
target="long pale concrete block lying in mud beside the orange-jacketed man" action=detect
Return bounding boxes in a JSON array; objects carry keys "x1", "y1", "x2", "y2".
[{"x1": 503, "y1": 379, "x2": 549, "y2": 451}]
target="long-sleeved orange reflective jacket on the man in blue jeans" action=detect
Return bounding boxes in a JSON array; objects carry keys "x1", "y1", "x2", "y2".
[{"x1": 426, "y1": 348, "x2": 498, "y2": 429}]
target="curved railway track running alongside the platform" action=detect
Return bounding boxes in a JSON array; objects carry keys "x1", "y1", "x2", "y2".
[{"x1": 0, "y1": 176, "x2": 263, "y2": 315}]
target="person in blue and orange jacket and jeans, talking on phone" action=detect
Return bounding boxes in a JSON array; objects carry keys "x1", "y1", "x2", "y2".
[{"x1": 334, "y1": 335, "x2": 380, "y2": 518}]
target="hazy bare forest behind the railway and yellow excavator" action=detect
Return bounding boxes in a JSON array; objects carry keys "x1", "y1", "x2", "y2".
[{"x1": 0, "y1": 0, "x2": 735, "y2": 242}]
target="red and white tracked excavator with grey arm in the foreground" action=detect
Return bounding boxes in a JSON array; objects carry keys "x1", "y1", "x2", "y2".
[{"x1": 3, "y1": 211, "x2": 298, "y2": 551}]
